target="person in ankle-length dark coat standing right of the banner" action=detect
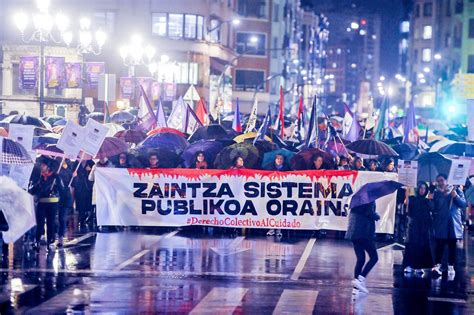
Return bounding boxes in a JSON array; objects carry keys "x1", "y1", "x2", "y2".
[{"x1": 403, "y1": 182, "x2": 433, "y2": 274}]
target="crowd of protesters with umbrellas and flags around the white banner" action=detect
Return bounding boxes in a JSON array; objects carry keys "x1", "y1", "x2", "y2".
[{"x1": 0, "y1": 90, "x2": 474, "y2": 291}]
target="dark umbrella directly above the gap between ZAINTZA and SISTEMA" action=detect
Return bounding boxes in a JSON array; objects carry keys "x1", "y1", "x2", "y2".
[{"x1": 214, "y1": 142, "x2": 260, "y2": 169}]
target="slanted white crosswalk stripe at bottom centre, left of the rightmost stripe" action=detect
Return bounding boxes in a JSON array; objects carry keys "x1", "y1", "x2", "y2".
[{"x1": 189, "y1": 288, "x2": 248, "y2": 315}]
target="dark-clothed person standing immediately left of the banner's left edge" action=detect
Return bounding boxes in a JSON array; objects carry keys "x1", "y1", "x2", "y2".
[{"x1": 72, "y1": 161, "x2": 95, "y2": 225}]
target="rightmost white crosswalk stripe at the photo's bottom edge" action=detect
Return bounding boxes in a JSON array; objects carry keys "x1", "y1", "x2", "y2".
[{"x1": 273, "y1": 289, "x2": 319, "y2": 315}]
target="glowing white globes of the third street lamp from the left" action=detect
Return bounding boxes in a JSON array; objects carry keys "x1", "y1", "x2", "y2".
[{"x1": 119, "y1": 34, "x2": 156, "y2": 77}]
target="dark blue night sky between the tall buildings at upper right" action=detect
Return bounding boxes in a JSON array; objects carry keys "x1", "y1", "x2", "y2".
[{"x1": 302, "y1": 0, "x2": 406, "y2": 75}]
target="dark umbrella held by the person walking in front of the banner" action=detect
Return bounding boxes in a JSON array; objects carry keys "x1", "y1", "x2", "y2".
[{"x1": 349, "y1": 180, "x2": 403, "y2": 209}]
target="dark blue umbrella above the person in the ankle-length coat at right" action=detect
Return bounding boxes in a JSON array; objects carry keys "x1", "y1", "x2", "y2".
[{"x1": 415, "y1": 152, "x2": 451, "y2": 183}]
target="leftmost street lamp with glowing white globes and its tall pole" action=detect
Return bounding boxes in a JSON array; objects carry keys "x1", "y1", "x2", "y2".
[{"x1": 14, "y1": 0, "x2": 72, "y2": 117}]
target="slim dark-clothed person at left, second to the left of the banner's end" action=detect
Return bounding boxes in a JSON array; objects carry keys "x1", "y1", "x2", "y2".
[{"x1": 58, "y1": 160, "x2": 73, "y2": 247}]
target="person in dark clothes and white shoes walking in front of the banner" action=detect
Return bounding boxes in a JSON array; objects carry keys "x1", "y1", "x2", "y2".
[{"x1": 346, "y1": 201, "x2": 380, "y2": 293}]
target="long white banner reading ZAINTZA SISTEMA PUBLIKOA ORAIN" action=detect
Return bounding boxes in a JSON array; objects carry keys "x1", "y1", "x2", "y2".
[{"x1": 94, "y1": 168, "x2": 397, "y2": 233}]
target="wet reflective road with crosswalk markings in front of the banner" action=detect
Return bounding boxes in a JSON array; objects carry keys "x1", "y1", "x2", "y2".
[{"x1": 0, "y1": 228, "x2": 474, "y2": 314}]
